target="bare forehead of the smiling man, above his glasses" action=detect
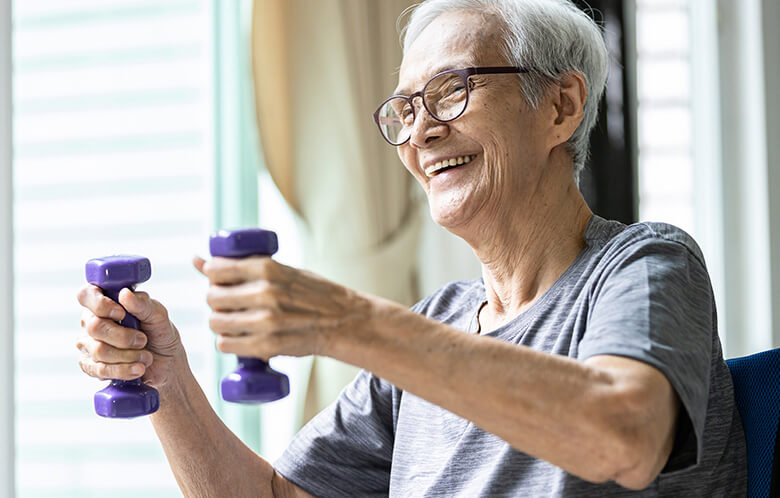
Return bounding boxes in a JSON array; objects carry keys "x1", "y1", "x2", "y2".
[{"x1": 396, "y1": 11, "x2": 504, "y2": 94}]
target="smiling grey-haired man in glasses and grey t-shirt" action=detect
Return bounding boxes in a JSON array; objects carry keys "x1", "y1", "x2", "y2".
[{"x1": 79, "y1": 0, "x2": 746, "y2": 497}]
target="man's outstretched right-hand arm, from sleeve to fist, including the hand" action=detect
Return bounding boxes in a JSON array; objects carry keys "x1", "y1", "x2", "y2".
[{"x1": 201, "y1": 258, "x2": 678, "y2": 488}]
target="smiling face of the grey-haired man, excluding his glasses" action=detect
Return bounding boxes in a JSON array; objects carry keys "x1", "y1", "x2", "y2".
[{"x1": 395, "y1": 11, "x2": 554, "y2": 231}]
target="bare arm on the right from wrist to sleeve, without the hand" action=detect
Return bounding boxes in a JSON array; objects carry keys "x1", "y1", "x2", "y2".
[{"x1": 324, "y1": 300, "x2": 679, "y2": 489}]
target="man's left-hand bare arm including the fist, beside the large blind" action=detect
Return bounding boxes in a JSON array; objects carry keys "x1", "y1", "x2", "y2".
[{"x1": 78, "y1": 286, "x2": 311, "y2": 497}]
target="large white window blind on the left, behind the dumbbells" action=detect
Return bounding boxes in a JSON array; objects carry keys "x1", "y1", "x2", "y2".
[{"x1": 13, "y1": 0, "x2": 216, "y2": 498}]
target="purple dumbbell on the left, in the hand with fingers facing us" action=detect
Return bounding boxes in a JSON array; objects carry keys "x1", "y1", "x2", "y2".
[{"x1": 86, "y1": 256, "x2": 160, "y2": 418}]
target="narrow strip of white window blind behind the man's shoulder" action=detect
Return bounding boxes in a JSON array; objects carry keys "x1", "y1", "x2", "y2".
[{"x1": 636, "y1": 0, "x2": 695, "y2": 234}]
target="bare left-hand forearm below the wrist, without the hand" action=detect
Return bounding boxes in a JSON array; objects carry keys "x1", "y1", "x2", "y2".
[{"x1": 151, "y1": 352, "x2": 274, "y2": 498}]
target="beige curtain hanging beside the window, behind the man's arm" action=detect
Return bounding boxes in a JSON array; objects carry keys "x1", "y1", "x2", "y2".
[{"x1": 252, "y1": 0, "x2": 420, "y2": 422}]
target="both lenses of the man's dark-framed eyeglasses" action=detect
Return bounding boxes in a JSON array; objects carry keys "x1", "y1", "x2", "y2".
[{"x1": 379, "y1": 73, "x2": 468, "y2": 145}]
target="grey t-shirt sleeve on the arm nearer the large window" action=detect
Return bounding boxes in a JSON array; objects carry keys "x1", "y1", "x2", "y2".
[{"x1": 274, "y1": 370, "x2": 394, "y2": 497}]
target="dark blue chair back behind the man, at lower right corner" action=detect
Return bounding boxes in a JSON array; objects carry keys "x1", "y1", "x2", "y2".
[{"x1": 726, "y1": 348, "x2": 780, "y2": 497}]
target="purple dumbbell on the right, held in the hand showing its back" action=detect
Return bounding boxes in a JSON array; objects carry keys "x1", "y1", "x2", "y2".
[{"x1": 209, "y1": 228, "x2": 290, "y2": 403}]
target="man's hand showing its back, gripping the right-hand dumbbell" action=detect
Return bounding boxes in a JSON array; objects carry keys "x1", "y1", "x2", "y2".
[{"x1": 193, "y1": 256, "x2": 371, "y2": 360}]
